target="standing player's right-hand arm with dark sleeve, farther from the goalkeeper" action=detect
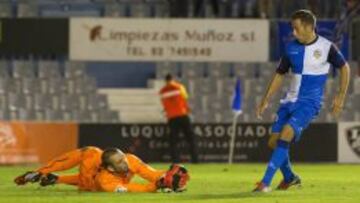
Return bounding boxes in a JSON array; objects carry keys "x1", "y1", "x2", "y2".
[{"x1": 328, "y1": 45, "x2": 350, "y2": 118}]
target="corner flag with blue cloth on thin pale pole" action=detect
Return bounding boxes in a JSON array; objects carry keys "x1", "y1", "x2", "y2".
[{"x1": 229, "y1": 79, "x2": 242, "y2": 164}]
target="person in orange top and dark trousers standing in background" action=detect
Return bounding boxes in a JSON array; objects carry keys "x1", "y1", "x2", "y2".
[{"x1": 160, "y1": 74, "x2": 198, "y2": 163}]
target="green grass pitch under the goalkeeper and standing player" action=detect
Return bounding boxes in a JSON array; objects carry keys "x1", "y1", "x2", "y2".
[{"x1": 0, "y1": 164, "x2": 360, "y2": 203}]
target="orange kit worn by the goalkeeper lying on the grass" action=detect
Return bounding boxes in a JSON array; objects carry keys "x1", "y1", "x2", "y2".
[{"x1": 37, "y1": 147, "x2": 164, "y2": 192}]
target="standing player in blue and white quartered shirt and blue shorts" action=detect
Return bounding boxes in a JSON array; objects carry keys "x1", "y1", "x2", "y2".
[{"x1": 253, "y1": 10, "x2": 350, "y2": 192}]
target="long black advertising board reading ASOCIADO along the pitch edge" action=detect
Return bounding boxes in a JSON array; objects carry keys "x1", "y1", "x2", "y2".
[{"x1": 79, "y1": 123, "x2": 337, "y2": 162}]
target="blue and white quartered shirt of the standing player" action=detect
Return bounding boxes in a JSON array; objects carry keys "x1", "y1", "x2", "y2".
[{"x1": 277, "y1": 36, "x2": 346, "y2": 107}]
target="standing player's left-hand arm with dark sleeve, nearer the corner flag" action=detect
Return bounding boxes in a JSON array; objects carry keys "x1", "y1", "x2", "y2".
[{"x1": 256, "y1": 56, "x2": 290, "y2": 118}]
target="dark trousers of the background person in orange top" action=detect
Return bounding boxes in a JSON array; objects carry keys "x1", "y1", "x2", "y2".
[{"x1": 168, "y1": 116, "x2": 198, "y2": 163}]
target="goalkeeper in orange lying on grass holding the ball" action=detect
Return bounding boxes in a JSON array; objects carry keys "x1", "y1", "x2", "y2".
[{"x1": 14, "y1": 147, "x2": 189, "y2": 192}]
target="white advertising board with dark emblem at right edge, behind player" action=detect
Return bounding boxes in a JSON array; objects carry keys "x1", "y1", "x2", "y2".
[{"x1": 338, "y1": 122, "x2": 360, "y2": 163}]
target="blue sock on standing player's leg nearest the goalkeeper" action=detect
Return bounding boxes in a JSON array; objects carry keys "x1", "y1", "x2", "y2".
[{"x1": 261, "y1": 140, "x2": 290, "y2": 186}]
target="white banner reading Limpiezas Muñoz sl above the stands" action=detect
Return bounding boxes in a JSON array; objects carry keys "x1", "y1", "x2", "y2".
[{"x1": 70, "y1": 18, "x2": 269, "y2": 62}]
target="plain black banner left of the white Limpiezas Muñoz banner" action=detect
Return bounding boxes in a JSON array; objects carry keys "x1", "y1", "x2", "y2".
[{"x1": 0, "y1": 18, "x2": 69, "y2": 55}]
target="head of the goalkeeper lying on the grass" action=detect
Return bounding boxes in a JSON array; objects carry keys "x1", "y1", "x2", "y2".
[{"x1": 101, "y1": 148, "x2": 129, "y2": 174}]
